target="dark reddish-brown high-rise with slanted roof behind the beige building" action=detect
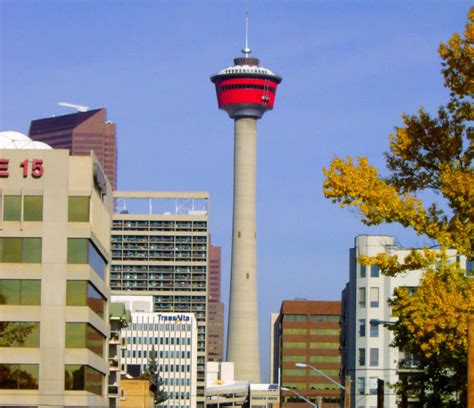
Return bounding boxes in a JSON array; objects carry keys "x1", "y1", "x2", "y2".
[{"x1": 28, "y1": 108, "x2": 117, "y2": 190}]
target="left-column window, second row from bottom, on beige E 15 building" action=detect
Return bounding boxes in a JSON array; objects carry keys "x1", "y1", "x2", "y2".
[{"x1": 0, "y1": 322, "x2": 40, "y2": 348}]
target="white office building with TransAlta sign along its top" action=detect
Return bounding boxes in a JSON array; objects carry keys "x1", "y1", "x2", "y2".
[{"x1": 113, "y1": 296, "x2": 198, "y2": 408}]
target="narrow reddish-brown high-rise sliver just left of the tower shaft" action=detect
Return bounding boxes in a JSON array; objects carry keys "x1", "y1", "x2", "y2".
[{"x1": 207, "y1": 245, "x2": 224, "y2": 362}]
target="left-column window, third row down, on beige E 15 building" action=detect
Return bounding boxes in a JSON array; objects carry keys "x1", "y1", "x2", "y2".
[{"x1": 0, "y1": 279, "x2": 41, "y2": 305}]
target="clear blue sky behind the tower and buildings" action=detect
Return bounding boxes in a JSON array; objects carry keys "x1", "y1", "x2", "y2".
[{"x1": 0, "y1": 0, "x2": 470, "y2": 381}]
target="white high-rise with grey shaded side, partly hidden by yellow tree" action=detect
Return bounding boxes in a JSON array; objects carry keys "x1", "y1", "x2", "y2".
[{"x1": 341, "y1": 235, "x2": 466, "y2": 408}]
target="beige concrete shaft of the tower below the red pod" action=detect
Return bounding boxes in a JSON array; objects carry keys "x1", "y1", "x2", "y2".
[{"x1": 227, "y1": 117, "x2": 260, "y2": 383}]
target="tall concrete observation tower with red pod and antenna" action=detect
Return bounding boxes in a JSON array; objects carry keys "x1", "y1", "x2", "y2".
[{"x1": 211, "y1": 19, "x2": 281, "y2": 383}]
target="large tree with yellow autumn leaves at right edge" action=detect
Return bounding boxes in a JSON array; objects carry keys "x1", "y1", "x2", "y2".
[{"x1": 323, "y1": 7, "x2": 474, "y2": 407}]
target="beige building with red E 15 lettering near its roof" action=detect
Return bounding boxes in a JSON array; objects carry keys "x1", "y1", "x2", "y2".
[{"x1": 0, "y1": 142, "x2": 113, "y2": 407}]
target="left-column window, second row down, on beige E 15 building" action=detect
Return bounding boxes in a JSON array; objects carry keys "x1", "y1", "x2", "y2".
[{"x1": 0, "y1": 238, "x2": 41, "y2": 263}]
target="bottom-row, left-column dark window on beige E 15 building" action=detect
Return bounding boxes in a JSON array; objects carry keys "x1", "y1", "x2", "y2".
[{"x1": 0, "y1": 364, "x2": 39, "y2": 390}]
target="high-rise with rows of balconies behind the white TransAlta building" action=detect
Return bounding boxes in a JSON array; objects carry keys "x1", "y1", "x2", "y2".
[{"x1": 110, "y1": 192, "x2": 209, "y2": 407}]
